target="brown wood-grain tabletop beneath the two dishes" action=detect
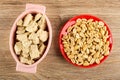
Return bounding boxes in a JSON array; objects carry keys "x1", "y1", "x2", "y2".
[{"x1": 0, "y1": 0, "x2": 120, "y2": 80}]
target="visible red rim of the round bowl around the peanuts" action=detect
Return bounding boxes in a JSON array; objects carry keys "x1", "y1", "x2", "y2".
[{"x1": 59, "y1": 14, "x2": 113, "y2": 68}]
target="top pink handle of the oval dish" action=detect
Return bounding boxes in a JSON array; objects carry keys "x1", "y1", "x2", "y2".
[{"x1": 25, "y1": 4, "x2": 46, "y2": 14}]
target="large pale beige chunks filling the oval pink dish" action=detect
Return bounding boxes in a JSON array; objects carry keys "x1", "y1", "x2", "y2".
[{"x1": 14, "y1": 13, "x2": 49, "y2": 65}]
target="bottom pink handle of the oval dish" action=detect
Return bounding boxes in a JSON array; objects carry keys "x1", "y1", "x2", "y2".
[{"x1": 16, "y1": 63, "x2": 37, "y2": 73}]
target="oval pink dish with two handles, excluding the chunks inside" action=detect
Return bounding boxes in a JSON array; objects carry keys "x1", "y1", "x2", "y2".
[{"x1": 9, "y1": 4, "x2": 52, "y2": 73}]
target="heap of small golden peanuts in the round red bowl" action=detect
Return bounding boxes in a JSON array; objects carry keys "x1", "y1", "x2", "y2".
[{"x1": 62, "y1": 19, "x2": 109, "y2": 66}]
